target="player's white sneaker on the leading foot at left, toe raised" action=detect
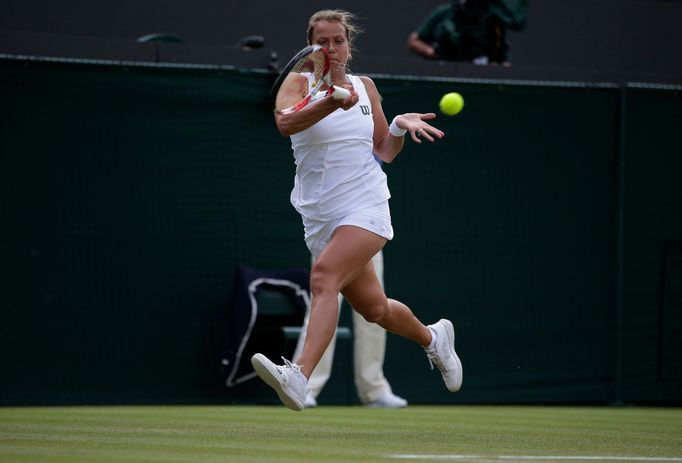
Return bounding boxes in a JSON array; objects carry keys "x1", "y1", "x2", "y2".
[{"x1": 251, "y1": 354, "x2": 308, "y2": 412}]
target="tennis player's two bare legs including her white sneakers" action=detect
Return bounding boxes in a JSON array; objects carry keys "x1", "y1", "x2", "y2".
[{"x1": 251, "y1": 225, "x2": 462, "y2": 411}]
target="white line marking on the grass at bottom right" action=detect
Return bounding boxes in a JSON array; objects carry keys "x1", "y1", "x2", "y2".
[{"x1": 386, "y1": 453, "x2": 682, "y2": 463}]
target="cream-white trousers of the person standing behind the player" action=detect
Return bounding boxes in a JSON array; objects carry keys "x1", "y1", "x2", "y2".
[{"x1": 294, "y1": 251, "x2": 392, "y2": 403}]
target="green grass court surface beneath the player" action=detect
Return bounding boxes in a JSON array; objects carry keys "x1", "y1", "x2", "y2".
[{"x1": 0, "y1": 406, "x2": 682, "y2": 463}]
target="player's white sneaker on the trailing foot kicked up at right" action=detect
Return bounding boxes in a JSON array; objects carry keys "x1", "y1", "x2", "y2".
[{"x1": 424, "y1": 318, "x2": 463, "y2": 392}]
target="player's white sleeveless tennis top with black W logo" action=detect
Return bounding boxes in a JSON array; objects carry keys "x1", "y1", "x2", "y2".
[{"x1": 290, "y1": 75, "x2": 391, "y2": 223}]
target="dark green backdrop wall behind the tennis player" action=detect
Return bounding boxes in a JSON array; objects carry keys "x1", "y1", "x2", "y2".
[{"x1": 0, "y1": 60, "x2": 682, "y2": 405}]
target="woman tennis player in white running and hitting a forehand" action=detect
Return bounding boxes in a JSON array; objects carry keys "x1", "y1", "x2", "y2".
[{"x1": 251, "y1": 10, "x2": 462, "y2": 411}]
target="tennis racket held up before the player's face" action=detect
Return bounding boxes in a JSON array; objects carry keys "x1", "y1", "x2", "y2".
[{"x1": 270, "y1": 45, "x2": 350, "y2": 114}]
